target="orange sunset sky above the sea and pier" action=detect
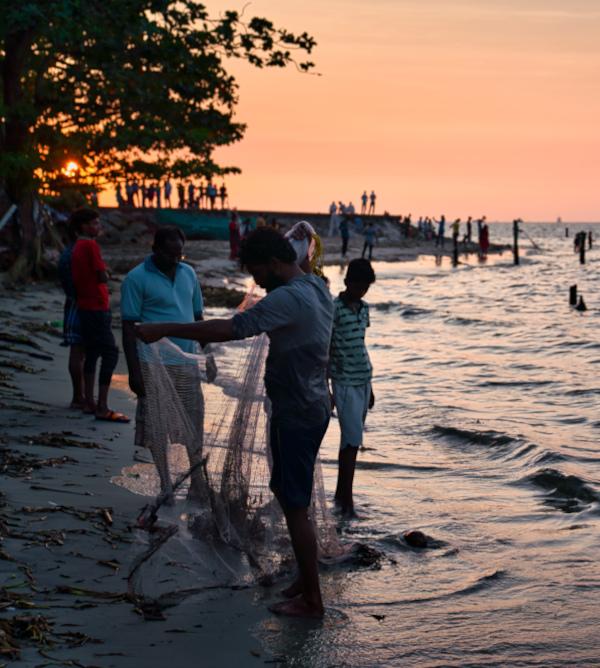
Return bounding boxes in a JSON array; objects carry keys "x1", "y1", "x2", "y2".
[{"x1": 104, "y1": 0, "x2": 600, "y2": 221}]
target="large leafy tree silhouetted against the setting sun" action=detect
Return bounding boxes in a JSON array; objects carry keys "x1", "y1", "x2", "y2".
[{"x1": 0, "y1": 0, "x2": 315, "y2": 272}]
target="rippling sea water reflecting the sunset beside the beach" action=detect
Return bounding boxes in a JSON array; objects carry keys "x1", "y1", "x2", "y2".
[{"x1": 255, "y1": 224, "x2": 600, "y2": 666}]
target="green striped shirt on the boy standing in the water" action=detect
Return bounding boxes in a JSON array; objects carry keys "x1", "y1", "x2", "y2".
[{"x1": 329, "y1": 297, "x2": 373, "y2": 385}]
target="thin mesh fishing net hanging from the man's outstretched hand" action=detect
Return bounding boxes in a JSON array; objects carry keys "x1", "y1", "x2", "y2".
[{"x1": 133, "y1": 296, "x2": 344, "y2": 579}]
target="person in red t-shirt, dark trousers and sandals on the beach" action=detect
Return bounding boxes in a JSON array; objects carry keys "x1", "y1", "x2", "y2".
[{"x1": 71, "y1": 209, "x2": 129, "y2": 422}]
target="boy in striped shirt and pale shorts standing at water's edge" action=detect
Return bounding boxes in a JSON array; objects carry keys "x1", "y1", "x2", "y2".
[{"x1": 329, "y1": 258, "x2": 375, "y2": 516}]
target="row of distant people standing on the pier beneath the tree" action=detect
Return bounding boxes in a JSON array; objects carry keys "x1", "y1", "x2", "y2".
[{"x1": 115, "y1": 179, "x2": 229, "y2": 211}]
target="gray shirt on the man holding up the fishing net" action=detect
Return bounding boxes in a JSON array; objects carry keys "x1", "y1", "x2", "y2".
[{"x1": 233, "y1": 274, "x2": 333, "y2": 426}]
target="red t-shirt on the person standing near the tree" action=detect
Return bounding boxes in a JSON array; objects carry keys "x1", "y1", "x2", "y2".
[{"x1": 71, "y1": 239, "x2": 108, "y2": 311}]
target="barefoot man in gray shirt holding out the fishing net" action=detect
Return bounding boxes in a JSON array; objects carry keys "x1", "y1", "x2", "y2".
[{"x1": 137, "y1": 228, "x2": 333, "y2": 617}]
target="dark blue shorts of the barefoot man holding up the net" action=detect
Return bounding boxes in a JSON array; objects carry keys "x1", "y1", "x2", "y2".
[{"x1": 270, "y1": 417, "x2": 329, "y2": 509}]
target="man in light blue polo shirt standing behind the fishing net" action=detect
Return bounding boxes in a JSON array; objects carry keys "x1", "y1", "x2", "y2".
[{"x1": 121, "y1": 226, "x2": 216, "y2": 497}]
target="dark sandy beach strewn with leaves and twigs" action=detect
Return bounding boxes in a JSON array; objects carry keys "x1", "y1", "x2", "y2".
[{"x1": 0, "y1": 226, "x2": 510, "y2": 668}]
